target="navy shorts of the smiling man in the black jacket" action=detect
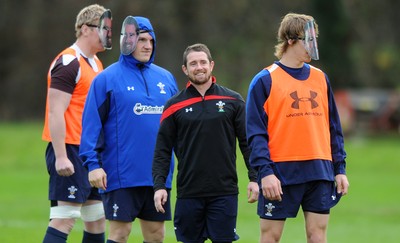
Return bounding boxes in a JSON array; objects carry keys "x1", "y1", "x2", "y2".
[{"x1": 174, "y1": 195, "x2": 239, "y2": 243}]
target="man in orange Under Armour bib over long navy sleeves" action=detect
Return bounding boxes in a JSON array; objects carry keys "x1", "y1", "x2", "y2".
[{"x1": 246, "y1": 13, "x2": 349, "y2": 243}]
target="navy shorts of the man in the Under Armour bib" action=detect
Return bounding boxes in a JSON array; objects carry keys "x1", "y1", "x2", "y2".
[{"x1": 257, "y1": 180, "x2": 341, "y2": 220}]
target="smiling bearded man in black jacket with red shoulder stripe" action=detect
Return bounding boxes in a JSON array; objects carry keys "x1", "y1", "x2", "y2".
[{"x1": 153, "y1": 44, "x2": 259, "y2": 242}]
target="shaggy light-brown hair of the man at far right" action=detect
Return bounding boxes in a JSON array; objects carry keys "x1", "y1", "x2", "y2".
[{"x1": 274, "y1": 13, "x2": 318, "y2": 59}]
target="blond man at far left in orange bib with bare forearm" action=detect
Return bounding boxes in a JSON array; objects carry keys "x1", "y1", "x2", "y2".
[{"x1": 42, "y1": 4, "x2": 112, "y2": 243}]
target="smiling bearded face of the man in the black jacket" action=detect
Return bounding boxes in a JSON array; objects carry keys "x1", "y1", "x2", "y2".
[{"x1": 182, "y1": 51, "x2": 214, "y2": 85}]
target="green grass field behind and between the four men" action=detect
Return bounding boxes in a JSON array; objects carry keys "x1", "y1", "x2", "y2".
[{"x1": 0, "y1": 122, "x2": 400, "y2": 243}]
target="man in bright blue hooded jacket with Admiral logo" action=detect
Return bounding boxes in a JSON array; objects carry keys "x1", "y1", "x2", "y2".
[{"x1": 80, "y1": 16, "x2": 178, "y2": 242}]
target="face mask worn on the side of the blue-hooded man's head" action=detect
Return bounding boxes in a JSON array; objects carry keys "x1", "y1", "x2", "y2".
[{"x1": 119, "y1": 16, "x2": 139, "y2": 55}]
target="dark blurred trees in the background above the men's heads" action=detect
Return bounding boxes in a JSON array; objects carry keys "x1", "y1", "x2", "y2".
[{"x1": 0, "y1": 0, "x2": 400, "y2": 121}]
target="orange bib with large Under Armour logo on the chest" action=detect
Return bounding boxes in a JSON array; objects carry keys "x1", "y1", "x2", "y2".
[{"x1": 264, "y1": 64, "x2": 332, "y2": 162}]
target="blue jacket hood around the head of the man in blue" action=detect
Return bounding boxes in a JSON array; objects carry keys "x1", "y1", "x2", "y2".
[{"x1": 119, "y1": 16, "x2": 156, "y2": 66}]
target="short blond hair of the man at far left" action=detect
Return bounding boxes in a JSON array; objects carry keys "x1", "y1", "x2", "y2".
[{"x1": 75, "y1": 4, "x2": 106, "y2": 38}]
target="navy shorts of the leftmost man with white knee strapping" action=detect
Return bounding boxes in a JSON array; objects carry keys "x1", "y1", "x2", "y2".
[{"x1": 46, "y1": 143, "x2": 101, "y2": 206}]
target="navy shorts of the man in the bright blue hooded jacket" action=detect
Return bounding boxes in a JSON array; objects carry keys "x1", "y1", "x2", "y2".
[{"x1": 101, "y1": 186, "x2": 171, "y2": 222}]
